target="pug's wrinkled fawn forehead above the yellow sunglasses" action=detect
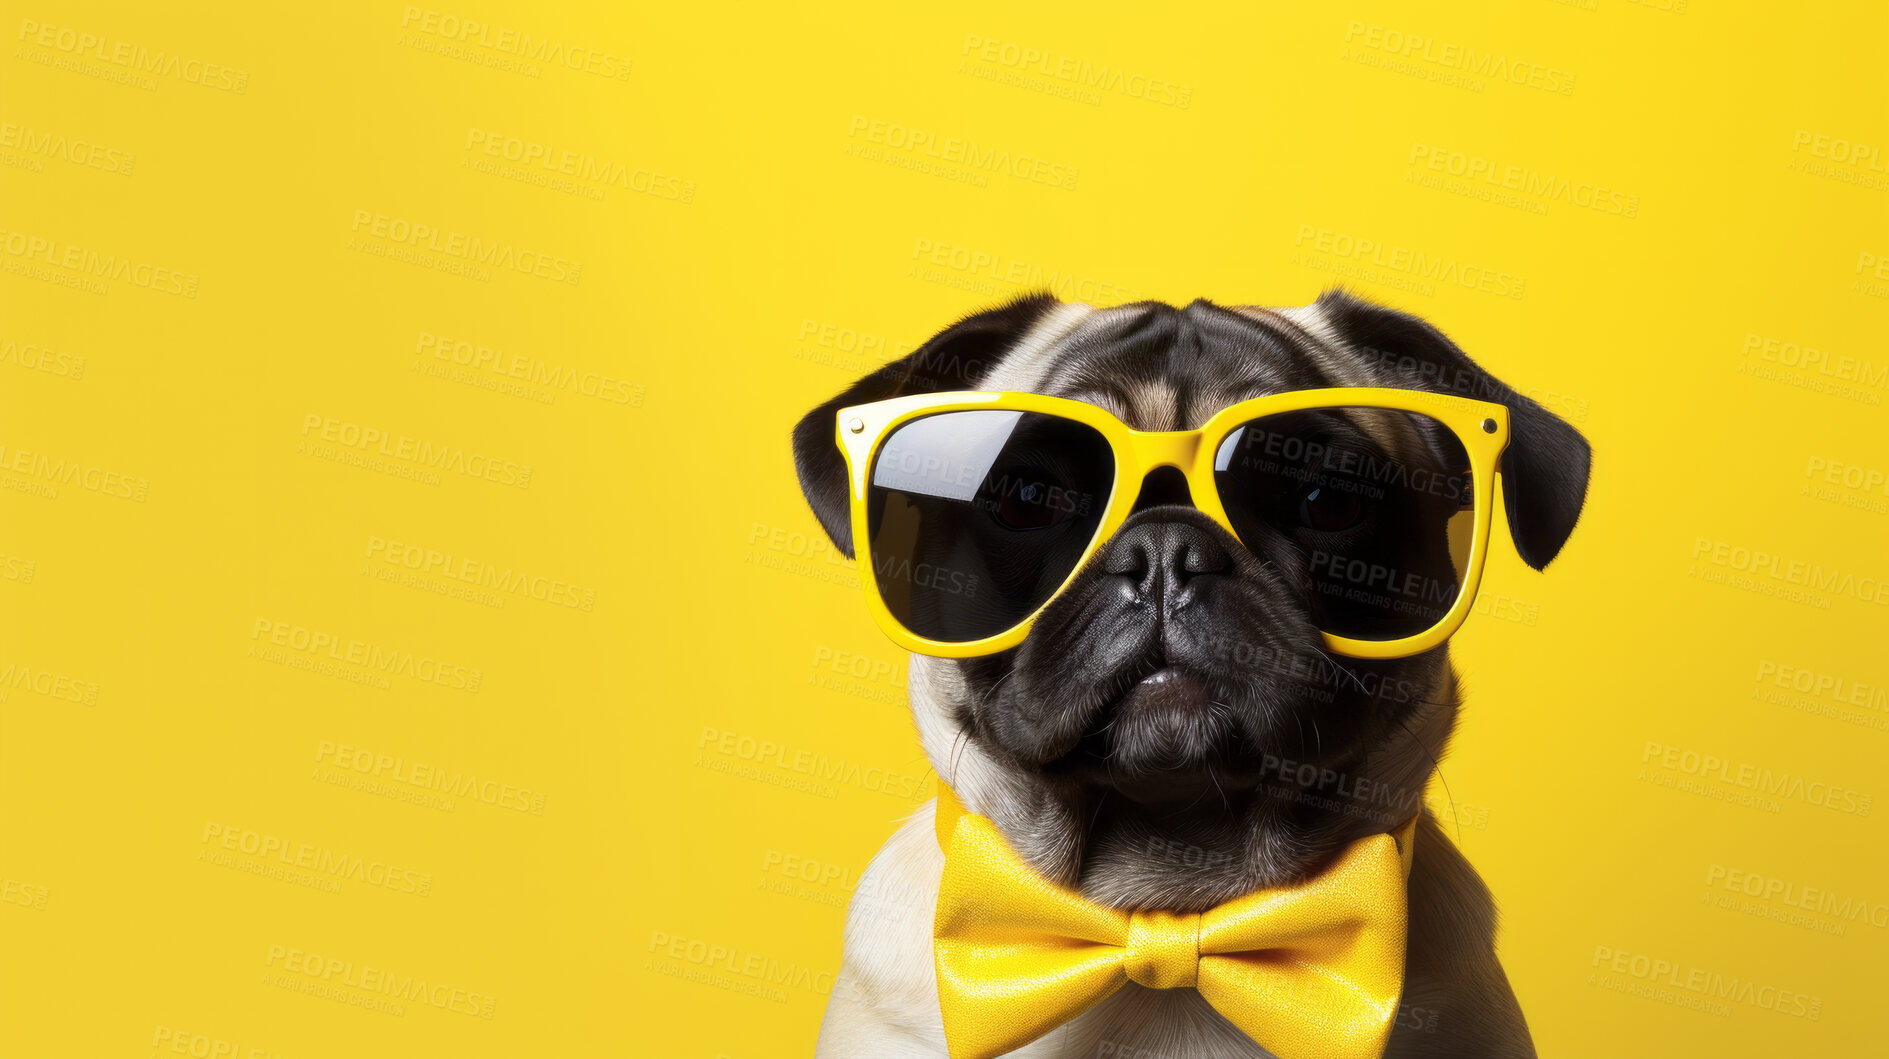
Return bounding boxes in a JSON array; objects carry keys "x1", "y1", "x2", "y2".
[{"x1": 977, "y1": 302, "x2": 1373, "y2": 430}]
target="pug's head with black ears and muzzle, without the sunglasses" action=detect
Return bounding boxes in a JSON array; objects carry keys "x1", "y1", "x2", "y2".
[{"x1": 795, "y1": 293, "x2": 1589, "y2": 908}]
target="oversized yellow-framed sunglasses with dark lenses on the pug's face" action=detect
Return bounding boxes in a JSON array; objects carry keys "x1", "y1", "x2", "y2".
[{"x1": 837, "y1": 387, "x2": 1509, "y2": 659}]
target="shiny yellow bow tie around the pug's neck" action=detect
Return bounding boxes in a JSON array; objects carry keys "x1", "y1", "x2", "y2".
[{"x1": 931, "y1": 783, "x2": 1417, "y2": 1059}]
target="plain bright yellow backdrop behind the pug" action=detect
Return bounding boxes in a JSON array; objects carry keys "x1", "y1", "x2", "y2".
[{"x1": 0, "y1": 0, "x2": 1889, "y2": 1059}]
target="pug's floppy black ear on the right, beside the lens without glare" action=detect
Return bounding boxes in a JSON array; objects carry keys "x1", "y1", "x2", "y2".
[{"x1": 1319, "y1": 291, "x2": 1592, "y2": 570}]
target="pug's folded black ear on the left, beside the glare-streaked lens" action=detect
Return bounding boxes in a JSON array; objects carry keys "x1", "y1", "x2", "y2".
[{"x1": 793, "y1": 293, "x2": 1062, "y2": 557}]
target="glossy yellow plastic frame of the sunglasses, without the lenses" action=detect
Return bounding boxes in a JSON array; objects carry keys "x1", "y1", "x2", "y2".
[{"x1": 835, "y1": 387, "x2": 1509, "y2": 659}]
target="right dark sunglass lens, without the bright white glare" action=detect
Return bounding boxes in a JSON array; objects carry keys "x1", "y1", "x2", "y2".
[{"x1": 1215, "y1": 408, "x2": 1475, "y2": 640}]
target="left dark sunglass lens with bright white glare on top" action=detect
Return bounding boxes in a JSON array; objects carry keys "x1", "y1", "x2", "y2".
[{"x1": 867, "y1": 410, "x2": 1115, "y2": 644}]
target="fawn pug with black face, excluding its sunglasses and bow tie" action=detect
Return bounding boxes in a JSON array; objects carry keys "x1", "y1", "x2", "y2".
[{"x1": 793, "y1": 291, "x2": 1589, "y2": 1059}]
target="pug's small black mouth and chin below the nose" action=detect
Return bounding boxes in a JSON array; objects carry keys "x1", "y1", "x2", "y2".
[{"x1": 1045, "y1": 663, "x2": 1262, "y2": 806}]
